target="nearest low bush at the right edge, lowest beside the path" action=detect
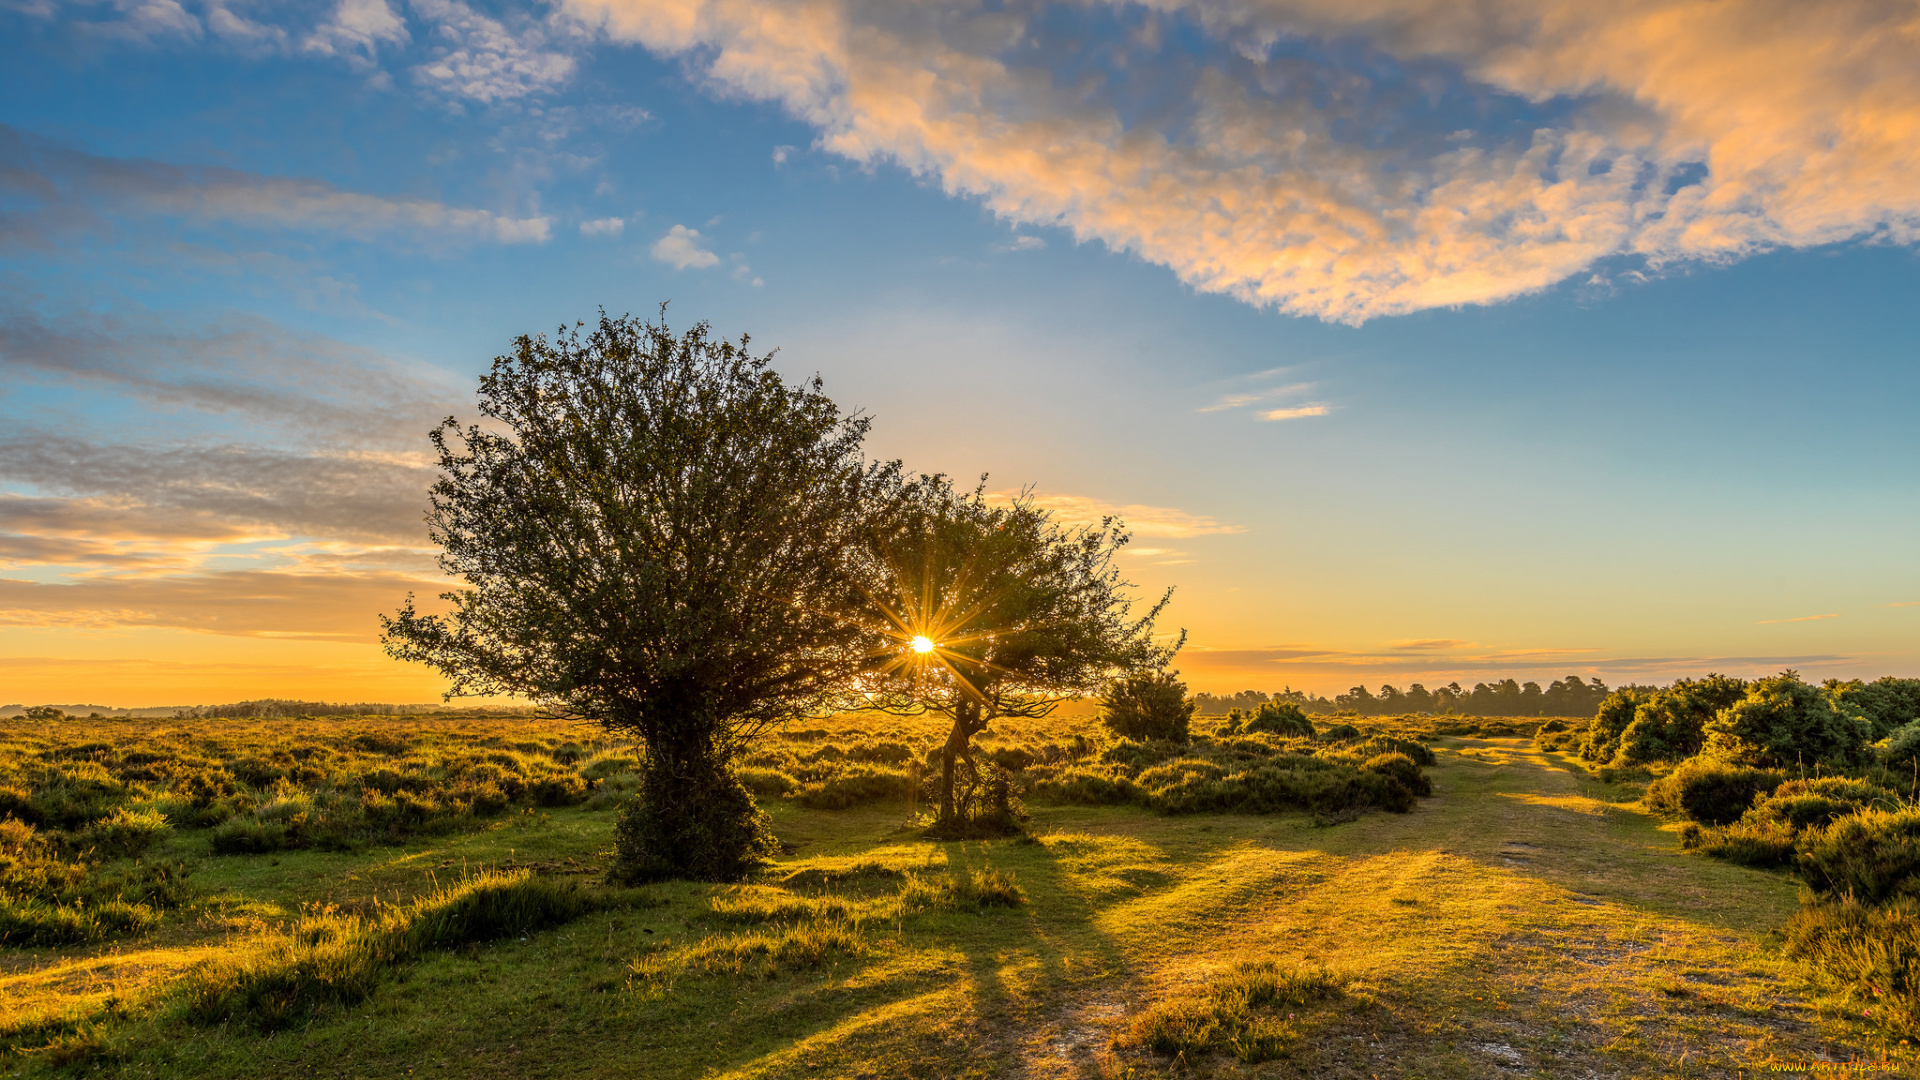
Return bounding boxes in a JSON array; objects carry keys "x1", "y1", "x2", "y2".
[{"x1": 1786, "y1": 897, "x2": 1920, "y2": 1038}]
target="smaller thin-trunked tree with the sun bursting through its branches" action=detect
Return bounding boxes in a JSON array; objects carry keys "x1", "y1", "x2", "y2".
[{"x1": 870, "y1": 477, "x2": 1179, "y2": 834}]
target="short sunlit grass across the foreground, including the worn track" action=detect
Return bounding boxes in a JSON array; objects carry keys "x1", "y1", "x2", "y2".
[{"x1": 0, "y1": 719, "x2": 1910, "y2": 1078}]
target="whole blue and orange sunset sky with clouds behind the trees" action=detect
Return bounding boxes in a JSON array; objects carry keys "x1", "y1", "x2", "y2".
[{"x1": 0, "y1": 0, "x2": 1920, "y2": 707}]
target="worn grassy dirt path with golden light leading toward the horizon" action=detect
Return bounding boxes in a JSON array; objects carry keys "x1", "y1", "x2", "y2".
[{"x1": 1023, "y1": 740, "x2": 1878, "y2": 1078}]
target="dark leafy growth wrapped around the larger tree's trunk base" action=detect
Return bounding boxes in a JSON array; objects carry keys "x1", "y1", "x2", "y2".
[{"x1": 611, "y1": 759, "x2": 778, "y2": 882}]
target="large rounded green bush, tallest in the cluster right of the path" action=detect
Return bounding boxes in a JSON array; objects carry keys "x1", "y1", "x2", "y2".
[{"x1": 1707, "y1": 671, "x2": 1874, "y2": 769}]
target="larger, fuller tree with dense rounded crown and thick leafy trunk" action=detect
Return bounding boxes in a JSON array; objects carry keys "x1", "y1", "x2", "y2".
[{"x1": 382, "y1": 307, "x2": 900, "y2": 880}]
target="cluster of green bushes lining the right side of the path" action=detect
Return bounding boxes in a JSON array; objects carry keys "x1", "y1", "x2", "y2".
[{"x1": 1534, "y1": 671, "x2": 1920, "y2": 1038}]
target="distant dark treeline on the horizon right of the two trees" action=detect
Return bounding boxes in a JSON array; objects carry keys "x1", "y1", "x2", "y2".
[{"x1": 1194, "y1": 675, "x2": 1630, "y2": 717}]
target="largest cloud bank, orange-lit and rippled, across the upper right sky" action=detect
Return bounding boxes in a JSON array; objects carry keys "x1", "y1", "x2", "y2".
[{"x1": 566, "y1": 0, "x2": 1920, "y2": 321}]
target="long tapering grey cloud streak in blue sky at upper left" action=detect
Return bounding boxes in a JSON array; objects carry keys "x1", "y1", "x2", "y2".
[{"x1": 0, "y1": 125, "x2": 551, "y2": 246}]
